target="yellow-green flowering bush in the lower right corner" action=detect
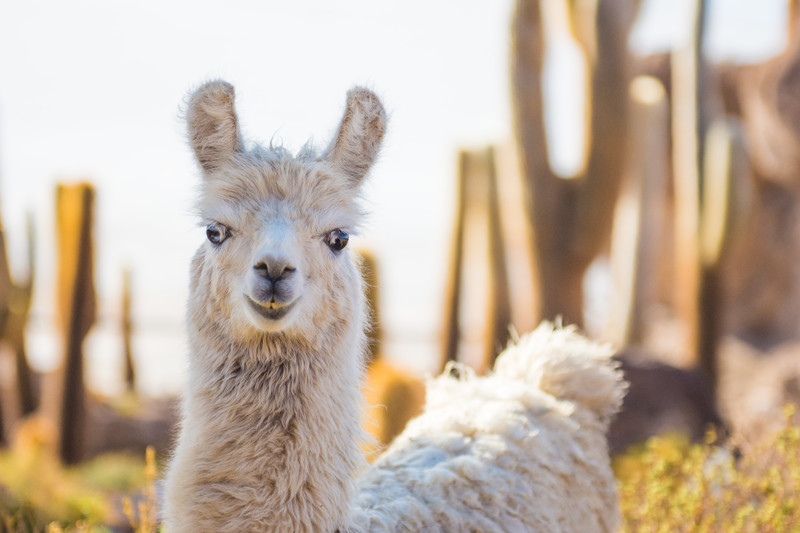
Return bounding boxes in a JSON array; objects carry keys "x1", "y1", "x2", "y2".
[{"x1": 614, "y1": 407, "x2": 800, "y2": 533}]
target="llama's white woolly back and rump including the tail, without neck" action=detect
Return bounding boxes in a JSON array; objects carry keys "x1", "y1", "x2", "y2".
[{"x1": 352, "y1": 323, "x2": 625, "y2": 532}]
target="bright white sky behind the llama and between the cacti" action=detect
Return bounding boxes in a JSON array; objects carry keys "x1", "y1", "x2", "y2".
[{"x1": 0, "y1": 0, "x2": 785, "y2": 394}]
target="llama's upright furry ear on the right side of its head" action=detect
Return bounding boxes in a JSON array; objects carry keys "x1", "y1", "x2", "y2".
[{"x1": 324, "y1": 87, "x2": 386, "y2": 185}]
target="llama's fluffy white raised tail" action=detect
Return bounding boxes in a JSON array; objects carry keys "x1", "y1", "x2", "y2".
[{"x1": 494, "y1": 322, "x2": 627, "y2": 426}]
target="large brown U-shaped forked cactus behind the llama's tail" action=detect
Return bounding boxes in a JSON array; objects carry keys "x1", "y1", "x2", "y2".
[{"x1": 511, "y1": 0, "x2": 638, "y2": 324}]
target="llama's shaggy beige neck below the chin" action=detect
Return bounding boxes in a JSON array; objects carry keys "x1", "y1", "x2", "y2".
[{"x1": 168, "y1": 314, "x2": 363, "y2": 531}]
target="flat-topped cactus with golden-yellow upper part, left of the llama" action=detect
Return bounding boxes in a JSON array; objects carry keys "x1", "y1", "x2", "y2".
[{"x1": 56, "y1": 183, "x2": 96, "y2": 464}]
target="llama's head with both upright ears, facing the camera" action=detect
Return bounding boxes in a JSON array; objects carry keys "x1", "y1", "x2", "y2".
[{"x1": 187, "y1": 81, "x2": 386, "y2": 337}]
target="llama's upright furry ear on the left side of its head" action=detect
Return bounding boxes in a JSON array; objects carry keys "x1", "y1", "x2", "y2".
[{"x1": 186, "y1": 80, "x2": 243, "y2": 173}]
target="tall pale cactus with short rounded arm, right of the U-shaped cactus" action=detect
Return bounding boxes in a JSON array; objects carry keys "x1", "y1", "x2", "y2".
[{"x1": 672, "y1": 0, "x2": 753, "y2": 385}]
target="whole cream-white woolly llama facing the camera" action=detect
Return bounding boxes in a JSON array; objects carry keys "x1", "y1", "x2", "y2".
[{"x1": 165, "y1": 81, "x2": 624, "y2": 533}]
